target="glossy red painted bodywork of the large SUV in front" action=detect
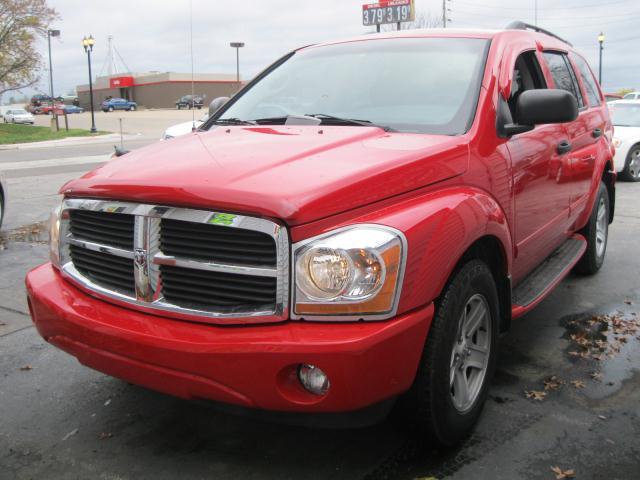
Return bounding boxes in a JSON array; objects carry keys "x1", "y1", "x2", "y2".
[{"x1": 27, "y1": 30, "x2": 612, "y2": 412}]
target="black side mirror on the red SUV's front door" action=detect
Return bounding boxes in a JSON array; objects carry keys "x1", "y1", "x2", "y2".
[{"x1": 504, "y1": 88, "x2": 578, "y2": 135}]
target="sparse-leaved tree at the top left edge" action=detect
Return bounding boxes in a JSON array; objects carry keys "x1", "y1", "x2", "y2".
[{"x1": 0, "y1": 0, "x2": 58, "y2": 95}]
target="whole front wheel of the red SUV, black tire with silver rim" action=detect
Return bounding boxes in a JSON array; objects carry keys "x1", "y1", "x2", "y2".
[{"x1": 398, "y1": 260, "x2": 499, "y2": 446}]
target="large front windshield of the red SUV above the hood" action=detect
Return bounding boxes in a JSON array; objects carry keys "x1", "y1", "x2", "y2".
[{"x1": 216, "y1": 38, "x2": 488, "y2": 135}]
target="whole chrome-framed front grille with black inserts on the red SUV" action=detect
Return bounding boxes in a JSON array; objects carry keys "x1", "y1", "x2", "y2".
[{"x1": 60, "y1": 199, "x2": 289, "y2": 323}]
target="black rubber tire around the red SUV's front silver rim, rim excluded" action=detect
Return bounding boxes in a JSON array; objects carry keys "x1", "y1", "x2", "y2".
[{"x1": 398, "y1": 260, "x2": 499, "y2": 446}]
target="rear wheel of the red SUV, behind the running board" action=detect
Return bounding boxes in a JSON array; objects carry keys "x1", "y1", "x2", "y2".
[{"x1": 574, "y1": 182, "x2": 609, "y2": 275}]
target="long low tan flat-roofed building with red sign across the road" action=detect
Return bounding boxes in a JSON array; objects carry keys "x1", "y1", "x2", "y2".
[{"x1": 76, "y1": 72, "x2": 242, "y2": 110}]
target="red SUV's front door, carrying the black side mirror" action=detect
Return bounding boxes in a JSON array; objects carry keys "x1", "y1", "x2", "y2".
[{"x1": 506, "y1": 49, "x2": 571, "y2": 283}]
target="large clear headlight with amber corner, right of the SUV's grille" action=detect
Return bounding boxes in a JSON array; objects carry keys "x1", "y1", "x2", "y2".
[{"x1": 292, "y1": 225, "x2": 406, "y2": 320}]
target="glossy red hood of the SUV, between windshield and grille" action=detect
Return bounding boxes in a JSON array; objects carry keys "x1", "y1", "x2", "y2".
[{"x1": 61, "y1": 126, "x2": 469, "y2": 225}]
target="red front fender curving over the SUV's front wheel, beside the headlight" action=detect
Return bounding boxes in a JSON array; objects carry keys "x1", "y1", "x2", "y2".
[{"x1": 291, "y1": 186, "x2": 513, "y2": 313}]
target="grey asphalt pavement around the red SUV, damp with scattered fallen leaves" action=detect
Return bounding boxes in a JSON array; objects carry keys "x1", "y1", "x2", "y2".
[{"x1": 0, "y1": 117, "x2": 640, "y2": 480}]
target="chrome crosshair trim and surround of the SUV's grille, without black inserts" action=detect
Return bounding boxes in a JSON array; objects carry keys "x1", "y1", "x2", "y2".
[{"x1": 60, "y1": 199, "x2": 289, "y2": 324}]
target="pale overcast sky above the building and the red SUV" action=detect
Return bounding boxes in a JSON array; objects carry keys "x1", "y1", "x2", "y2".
[{"x1": 25, "y1": 0, "x2": 640, "y2": 98}]
